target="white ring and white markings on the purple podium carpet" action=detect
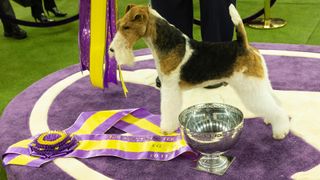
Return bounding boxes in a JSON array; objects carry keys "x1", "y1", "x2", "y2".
[{"x1": 29, "y1": 50, "x2": 320, "y2": 179}]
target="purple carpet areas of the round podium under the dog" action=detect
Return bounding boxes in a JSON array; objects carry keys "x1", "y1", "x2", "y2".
[{"x1": 0, "y1": 44, "x2": 320, "y2": 180}]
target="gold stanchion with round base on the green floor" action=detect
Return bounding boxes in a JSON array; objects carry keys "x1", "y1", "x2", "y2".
[{"x1": 247, "y1": 0, "x2": 287, "y2": 29}]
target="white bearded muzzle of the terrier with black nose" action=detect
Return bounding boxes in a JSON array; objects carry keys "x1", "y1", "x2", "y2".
[{"x1": 109, "y1": 33, "x2": 134, "y2": 65}]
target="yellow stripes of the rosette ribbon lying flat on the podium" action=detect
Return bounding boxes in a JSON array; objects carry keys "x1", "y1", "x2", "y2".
[{"x1": 4, "y1": 110, "x2": 187, "y2": 165}]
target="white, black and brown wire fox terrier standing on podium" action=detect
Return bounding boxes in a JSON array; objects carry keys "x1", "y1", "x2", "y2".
[{"x1": 109, "y1": 4, "x2": 290, "y2": 139}]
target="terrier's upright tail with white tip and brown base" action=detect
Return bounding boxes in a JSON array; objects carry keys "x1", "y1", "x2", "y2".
[{"x1": 229, "y1": 4, "x2": 249, "y2": 49}]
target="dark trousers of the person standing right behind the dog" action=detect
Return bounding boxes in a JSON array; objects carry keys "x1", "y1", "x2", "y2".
[{"x1": 151, "y1": 0, "x2": 236, "y2": 42}]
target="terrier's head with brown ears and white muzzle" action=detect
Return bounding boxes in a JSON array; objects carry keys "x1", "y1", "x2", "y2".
[{"x1": 109, "y1": 5, "x2": 149, "y2": 65}]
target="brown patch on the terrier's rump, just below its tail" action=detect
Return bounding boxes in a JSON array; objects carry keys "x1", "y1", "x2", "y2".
[{"x1": 234, "y1": 47, "x2": 265, "y2": 78}]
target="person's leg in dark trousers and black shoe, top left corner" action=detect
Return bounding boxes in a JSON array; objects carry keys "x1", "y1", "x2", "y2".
[{"x1": 0, "y1": 0, "x2": 27, "y2": 39}]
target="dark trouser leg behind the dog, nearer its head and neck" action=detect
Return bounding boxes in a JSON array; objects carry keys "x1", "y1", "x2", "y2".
[{"x1": 151, "y1": 0, "x2": 193, "y2": 38}]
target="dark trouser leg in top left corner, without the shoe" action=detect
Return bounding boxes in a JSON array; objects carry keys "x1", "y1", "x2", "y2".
[{"x1": 0, "y1": 0, "x2": 17, "y2": 32}]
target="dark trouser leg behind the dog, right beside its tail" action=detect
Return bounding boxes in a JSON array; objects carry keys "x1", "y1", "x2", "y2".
[{"x1": 200, "y1": 0, "x2": 236, "y2": 42}]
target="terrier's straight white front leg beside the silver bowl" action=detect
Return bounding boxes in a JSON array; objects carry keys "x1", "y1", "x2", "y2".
[{"x1": 160, "y1": 80, "x2": 182, "y2": 133}]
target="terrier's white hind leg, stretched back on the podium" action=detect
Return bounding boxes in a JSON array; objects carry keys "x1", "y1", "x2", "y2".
[{"x1": 229, "y1": 73, "x2": 290, "y2": 139}]
